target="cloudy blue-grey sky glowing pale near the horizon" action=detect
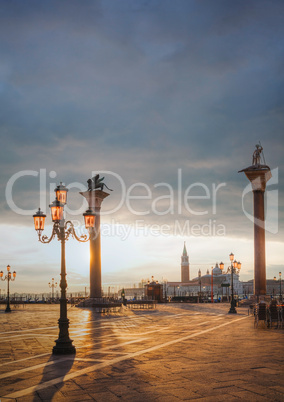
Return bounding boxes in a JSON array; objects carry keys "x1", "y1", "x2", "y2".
[{"x1": 0, "y1": 0, "x2": 284, "y2": 292}]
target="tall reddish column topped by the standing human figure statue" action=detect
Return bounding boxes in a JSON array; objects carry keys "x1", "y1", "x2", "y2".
[{"x1": 239, "y1": 144, "x2": 271, "y2": 300}]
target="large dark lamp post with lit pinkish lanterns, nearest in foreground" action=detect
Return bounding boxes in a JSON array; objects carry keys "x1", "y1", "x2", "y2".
[{"x1": 33, "y1": 183, "x2": 95, "y2": 354}]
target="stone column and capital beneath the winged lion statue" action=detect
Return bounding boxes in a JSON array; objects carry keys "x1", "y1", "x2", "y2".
[{"x1": 80, "y1": 190, "x2": 109, "y2": 298}]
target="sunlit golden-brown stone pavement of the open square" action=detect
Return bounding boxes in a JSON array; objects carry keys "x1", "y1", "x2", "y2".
[{"x1": 0, "y1": 304, "x2": 284, "y2": 402}]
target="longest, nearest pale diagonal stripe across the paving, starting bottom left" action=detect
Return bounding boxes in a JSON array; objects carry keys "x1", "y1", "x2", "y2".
[{"x1": 2, "y1": 316, "x2": 247, "y2": 398}]
